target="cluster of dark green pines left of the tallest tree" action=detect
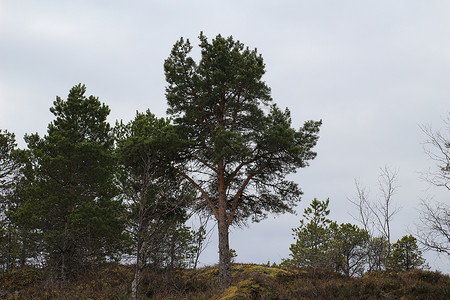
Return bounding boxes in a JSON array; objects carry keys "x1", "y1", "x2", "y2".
[{"x1": 0, "y1": 84, "x2": 204, "y2": 280}]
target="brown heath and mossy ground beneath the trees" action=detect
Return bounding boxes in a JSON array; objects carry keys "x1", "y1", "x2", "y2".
[{"x1": 0, "y1": 263, "x2": 450, "y2": 299}]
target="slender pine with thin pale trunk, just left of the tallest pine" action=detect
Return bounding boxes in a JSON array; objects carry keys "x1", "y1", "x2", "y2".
[{"x1": 115, "y1": 110, "x2": 192, "y2": 299}]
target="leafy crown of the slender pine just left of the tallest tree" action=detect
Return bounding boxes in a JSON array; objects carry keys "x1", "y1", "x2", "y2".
[{"x1": 115, "y1": 111, "x2": 189, "y2": 234}]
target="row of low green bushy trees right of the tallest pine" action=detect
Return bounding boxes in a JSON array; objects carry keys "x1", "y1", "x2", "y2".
[{"x1": 282, "y1": 199, "x2": 427, "y2": 276}]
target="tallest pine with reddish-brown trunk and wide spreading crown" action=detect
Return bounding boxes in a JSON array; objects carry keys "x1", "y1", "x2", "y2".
[{"x1": 164, "y1": 34, "x2": 321, "y2": 289}]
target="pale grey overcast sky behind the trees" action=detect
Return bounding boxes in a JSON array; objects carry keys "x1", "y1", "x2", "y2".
[{"x1": 0, "y1": 0, "x2": 450, "y2": 273}]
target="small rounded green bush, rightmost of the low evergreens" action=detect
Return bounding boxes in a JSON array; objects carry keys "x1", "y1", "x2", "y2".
[{"x1": 389, "y1": 235, "x2": 425, "y2": 271}]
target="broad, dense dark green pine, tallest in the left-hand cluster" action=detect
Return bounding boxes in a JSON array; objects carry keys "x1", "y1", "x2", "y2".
[{"x1": 16, "y1": 84, "x2": 124, "y2": 278}]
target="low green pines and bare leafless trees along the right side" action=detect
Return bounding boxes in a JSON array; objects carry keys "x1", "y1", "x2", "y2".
[{"x1": 282, "y1": 117, "x2": 450, "y2": 276}]
